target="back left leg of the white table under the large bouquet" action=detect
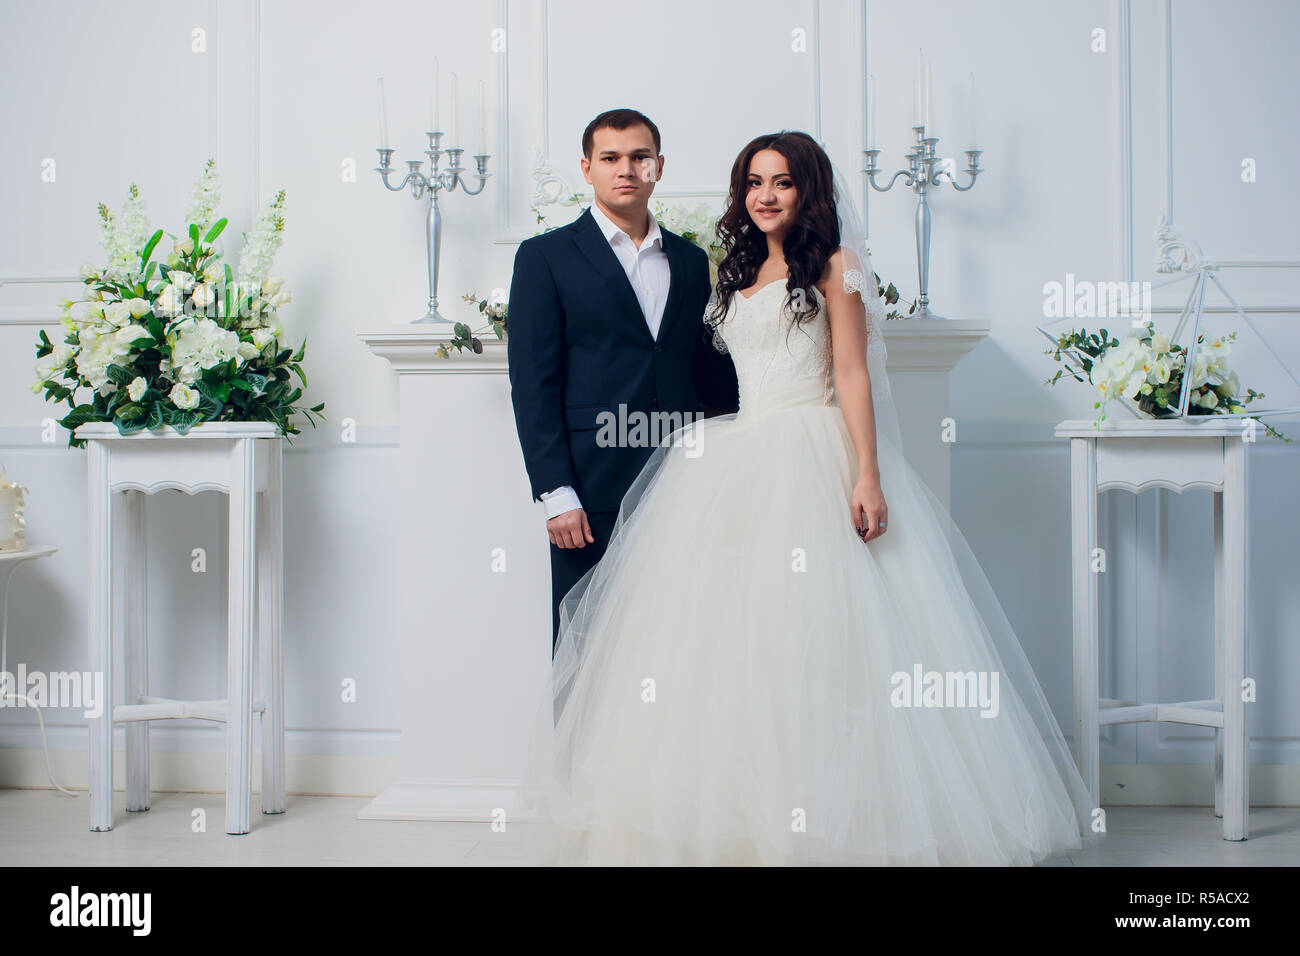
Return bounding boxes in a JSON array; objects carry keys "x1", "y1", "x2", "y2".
[{"x1": 117, "y1": 489, "x2": 150, "y2": 810}]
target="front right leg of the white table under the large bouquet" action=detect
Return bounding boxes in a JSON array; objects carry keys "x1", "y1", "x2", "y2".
[{"x1": 226, "y1": 438, "x2": 257, "y2": 834}]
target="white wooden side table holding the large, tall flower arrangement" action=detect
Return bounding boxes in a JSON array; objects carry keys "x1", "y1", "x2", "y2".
[{"x1": 75, "y1": 421, "x2": 285, "y2": 834}]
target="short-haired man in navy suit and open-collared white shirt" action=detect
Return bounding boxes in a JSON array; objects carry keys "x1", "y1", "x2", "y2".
[{"x1": 507, "y1": 109, "x2": 738, "y2": 656}]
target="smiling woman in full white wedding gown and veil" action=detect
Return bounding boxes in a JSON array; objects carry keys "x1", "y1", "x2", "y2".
[{"x1": 521, "y1": 131, "x2": 1104, "y2": 865}]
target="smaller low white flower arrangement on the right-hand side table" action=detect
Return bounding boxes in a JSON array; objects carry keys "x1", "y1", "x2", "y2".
[{"x1": 1045, "y1": 319, "x2": 1291, "y2": 441}]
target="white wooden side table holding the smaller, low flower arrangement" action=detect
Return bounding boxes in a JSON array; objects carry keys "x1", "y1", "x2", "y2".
[{"x1": 1056, "y1": 416, "x2": 1264, "y2": 840}]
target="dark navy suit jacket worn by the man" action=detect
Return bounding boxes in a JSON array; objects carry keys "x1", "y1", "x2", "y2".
[{"x1": 506, "y1": 204, "x2": 740, "y2": 514}]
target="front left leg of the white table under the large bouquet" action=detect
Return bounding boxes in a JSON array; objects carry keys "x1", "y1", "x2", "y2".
[{"x1": 86, "y1": 441, "x2": 114, "y2": 830}]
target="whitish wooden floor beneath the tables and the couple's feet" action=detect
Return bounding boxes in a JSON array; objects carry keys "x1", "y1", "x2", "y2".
[{"x1": 0, "y1": 790, "x2": 1300, "y2": 866}]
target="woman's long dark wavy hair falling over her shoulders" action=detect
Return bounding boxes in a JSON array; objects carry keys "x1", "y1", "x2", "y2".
[{"x1": 711, "y1": 130, "x2": 840, "y2": 324}]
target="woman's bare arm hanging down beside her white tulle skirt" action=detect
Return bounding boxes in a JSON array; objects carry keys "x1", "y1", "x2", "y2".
[{"x1": 823, "y1": 248, "x2": 887, "y2": 541}]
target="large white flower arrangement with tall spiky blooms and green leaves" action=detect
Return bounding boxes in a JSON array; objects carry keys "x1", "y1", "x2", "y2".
[{"x1": 31, "y1": 159, "x2": 325, "y2": 446}]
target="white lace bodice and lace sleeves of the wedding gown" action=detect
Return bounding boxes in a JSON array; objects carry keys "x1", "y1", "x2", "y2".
[{"x1": 709, "y1": 277, "x2": 888, "y2": 414}]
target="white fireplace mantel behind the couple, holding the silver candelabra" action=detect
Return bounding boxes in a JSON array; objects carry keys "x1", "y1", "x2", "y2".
[{"x1": 358, "y1": 320, "x2": 988, "y2": 821}]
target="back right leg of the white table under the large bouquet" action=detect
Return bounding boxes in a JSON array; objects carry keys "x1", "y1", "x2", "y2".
[{"x1": 257, "y1": 438, "x2": 285, "y2": 813}]
